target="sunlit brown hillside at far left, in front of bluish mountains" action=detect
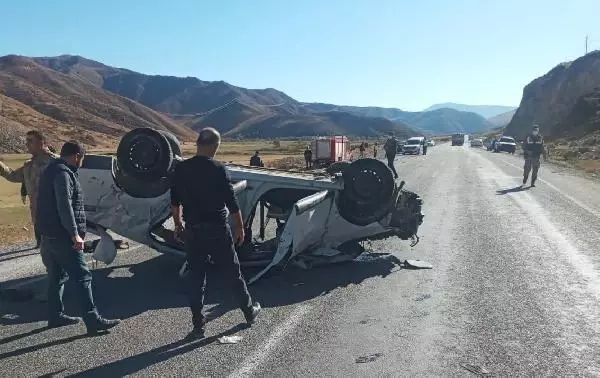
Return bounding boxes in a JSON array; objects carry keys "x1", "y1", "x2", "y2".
[{"x1": 0, "y1": 55, "x2": 195, "y2": 151}]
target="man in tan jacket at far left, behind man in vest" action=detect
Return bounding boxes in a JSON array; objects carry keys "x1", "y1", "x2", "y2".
[{"x1": 0, "y1": 130, "x2": 58, "y2": 248}]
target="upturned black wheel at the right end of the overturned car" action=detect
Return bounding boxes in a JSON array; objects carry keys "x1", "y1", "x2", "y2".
[{"x1": 337, "y1": 158, "x2": 395, "y2": 226}]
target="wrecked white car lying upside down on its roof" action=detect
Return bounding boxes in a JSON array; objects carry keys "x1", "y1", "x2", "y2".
[{"x1": 79, "y1": 128, "x2": 423, "y2": 282}]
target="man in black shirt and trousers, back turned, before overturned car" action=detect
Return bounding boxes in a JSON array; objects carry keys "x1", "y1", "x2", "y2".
[{"x1": 171, "y1": 127, "x2": 260, "y2": 339}]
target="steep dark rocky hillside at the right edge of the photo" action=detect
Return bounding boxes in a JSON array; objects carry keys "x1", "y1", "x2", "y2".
[{"x1": 506, "y1": 51, "x2": 600, "y2": 138}]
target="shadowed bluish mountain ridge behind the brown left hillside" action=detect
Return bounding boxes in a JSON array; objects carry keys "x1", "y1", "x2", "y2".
[{"x1": 30, "y1": 55, "x2": 490, "y2": 137}]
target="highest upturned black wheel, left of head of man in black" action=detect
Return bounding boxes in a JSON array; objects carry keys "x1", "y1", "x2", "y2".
[{"x1": 117, "y1": 127, "x2": 174, "y2": 182}]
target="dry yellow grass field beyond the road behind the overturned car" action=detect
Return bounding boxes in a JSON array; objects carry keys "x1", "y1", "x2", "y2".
[{"x1": 0, "y1": 140, "x2": 306, "y2": 244}]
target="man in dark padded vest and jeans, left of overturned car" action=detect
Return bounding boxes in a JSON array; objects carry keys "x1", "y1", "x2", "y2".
[{"x1": 36, "y1": 141, "x2": 120, "y2": 335}]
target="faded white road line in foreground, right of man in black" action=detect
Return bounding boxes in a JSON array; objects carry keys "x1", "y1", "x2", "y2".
[{"x1": 230, "y1": 304, "x2": 311, "y2": 377}]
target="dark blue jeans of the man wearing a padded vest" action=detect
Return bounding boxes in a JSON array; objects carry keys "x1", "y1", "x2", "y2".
[{"x1": 40, "y1": 235, "x2": 98, "y2": 324}]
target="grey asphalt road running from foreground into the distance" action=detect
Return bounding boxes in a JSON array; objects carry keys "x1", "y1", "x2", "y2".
[{"x1": 0, "y1": 144, "x2": 600, "y2": 377}]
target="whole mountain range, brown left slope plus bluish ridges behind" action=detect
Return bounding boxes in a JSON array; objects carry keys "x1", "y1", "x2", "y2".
[{"x1": 0, "y1": 55, "x2": 504, "y2": 150}]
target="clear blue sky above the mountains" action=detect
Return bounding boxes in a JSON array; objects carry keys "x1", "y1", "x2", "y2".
[{"x1": 0, "y1": 0, "x2": 600, "y2": 110}]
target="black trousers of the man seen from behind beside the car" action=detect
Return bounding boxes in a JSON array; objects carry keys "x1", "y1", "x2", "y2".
[{"x1": 185, "y1": 222, "x2": 252, "y2": 328}]
